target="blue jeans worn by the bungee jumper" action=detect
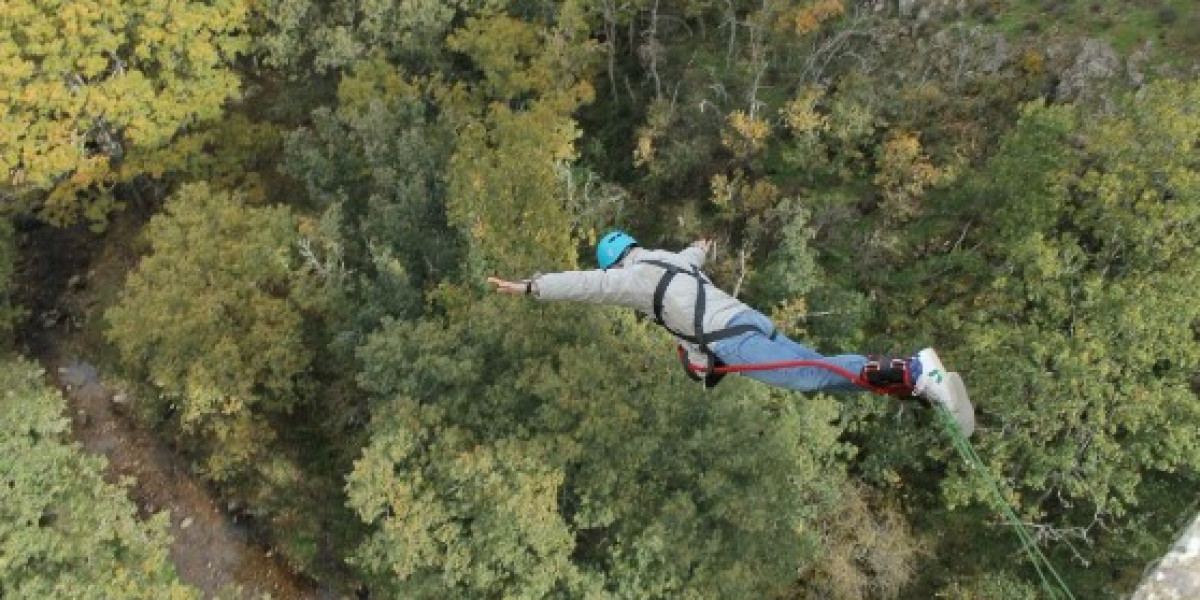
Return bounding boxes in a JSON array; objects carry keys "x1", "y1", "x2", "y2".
[{"x1": 709, "y1": 308, "x2": 866, "y2": 391}]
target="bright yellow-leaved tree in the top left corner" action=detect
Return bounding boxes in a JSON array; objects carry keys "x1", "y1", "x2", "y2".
[{"x1": 0, "y1": 0, "x2": 247, "y2": 223}]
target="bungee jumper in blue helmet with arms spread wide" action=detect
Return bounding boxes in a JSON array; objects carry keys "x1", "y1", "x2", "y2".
[{"x1": 487, "y1": 230, "x2": 974, "y2": 436}]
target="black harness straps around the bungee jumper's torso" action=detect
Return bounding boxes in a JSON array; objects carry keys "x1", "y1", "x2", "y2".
[{"x1": 638, "y1": 259, "x2": 775, "y2": 388}]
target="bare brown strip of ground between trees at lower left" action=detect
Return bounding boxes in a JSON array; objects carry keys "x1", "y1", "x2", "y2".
[{"x1": 17, "y1": 213, "x2": 342, "y2": 600}]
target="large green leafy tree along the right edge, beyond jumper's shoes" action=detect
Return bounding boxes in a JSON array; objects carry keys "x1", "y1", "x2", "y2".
[{"x1": 945, "y1": 83, "x2": 1200, "y2": 517}]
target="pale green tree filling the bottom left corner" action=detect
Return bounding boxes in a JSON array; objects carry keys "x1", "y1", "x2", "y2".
[{"x1": 0, "y1": 359, "x2": 200, "y2": 600}]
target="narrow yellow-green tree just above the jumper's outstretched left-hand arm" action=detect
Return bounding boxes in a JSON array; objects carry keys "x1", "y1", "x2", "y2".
[{"x1": 438, "y1": 16, "x2": 592, "y2": 275}]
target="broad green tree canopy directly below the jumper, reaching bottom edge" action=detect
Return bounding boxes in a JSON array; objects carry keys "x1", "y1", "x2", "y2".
[{"x1": 348, "y1": 297, "x2": 854, "y2": 598}]
